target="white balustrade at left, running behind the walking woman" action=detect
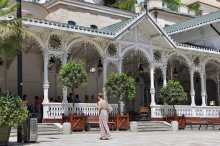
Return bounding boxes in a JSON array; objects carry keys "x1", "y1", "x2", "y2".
[{"x1": 43, "y1": 103, "x2": 118, "y2": 119}]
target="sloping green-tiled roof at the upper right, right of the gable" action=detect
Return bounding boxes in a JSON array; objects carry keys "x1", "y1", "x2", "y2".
[{"x1": 164, "y1": 11, "x2": 220, "y2": 54}]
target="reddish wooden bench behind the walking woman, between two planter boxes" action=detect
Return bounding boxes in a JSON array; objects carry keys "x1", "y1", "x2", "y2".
[{"x1": 86, "y1": 116, "x2": 116, "y2": 131}]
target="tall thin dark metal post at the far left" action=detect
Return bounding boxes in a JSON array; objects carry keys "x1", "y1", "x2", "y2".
[{"x1": 16, "y1": 0, "x2": 23, "y2": 143}]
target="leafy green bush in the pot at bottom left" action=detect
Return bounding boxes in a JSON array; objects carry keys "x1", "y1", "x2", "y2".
[{"x1": 0, "y1": 94, "x2": 28, "y2": 127}]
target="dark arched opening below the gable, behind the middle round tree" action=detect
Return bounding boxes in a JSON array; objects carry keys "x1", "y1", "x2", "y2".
[{"x1": 122, "y1": 50, "x2": 151, "y2": 112}]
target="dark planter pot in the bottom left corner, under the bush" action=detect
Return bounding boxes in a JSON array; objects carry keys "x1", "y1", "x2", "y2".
[{"x1": 0, "y1": 127, "x2": 11, "y2": 146}]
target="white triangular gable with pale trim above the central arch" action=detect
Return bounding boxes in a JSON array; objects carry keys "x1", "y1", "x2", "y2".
[{"x1": 118, "y1": 14, "x2": 175, "y2": 48}]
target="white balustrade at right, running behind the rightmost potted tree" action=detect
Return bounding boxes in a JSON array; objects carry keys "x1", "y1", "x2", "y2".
[{"x1": 151, "y1": 105, "x2": 220, "y2": 118}]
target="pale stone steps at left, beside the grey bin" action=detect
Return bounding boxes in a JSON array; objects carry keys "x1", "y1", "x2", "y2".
[{"x1": 10, "y1": 123, "x2": 63, "y2": 137}]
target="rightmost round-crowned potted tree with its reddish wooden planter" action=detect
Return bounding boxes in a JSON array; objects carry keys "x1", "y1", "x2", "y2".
[{"x1": 160, "y1": 80, "x2": 187, "y2": 130}]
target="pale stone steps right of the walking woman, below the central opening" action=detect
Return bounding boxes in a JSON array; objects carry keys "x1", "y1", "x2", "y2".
[{"x1": 137, "y1": 121, "x2": 172, "y2": 132}]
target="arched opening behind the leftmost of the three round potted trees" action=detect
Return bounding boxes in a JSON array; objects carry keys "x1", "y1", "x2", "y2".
[{"x1": 68, "y1": 41, "x2": 103, "y2": 103}]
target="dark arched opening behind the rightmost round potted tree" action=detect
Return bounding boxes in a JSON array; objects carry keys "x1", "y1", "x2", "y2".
[{"x1": 167, "y1": 55, "x2": 191, "y2": 105}]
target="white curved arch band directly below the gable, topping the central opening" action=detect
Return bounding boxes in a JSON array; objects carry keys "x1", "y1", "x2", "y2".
[{"x1": 120, "y1": 45, "x2": 153, "y2": 63}]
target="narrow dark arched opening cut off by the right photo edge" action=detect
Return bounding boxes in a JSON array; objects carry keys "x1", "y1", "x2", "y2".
[{"x1": 205, "y1": 60, "x2": 220, "y2": 106}]
